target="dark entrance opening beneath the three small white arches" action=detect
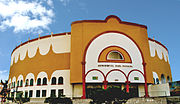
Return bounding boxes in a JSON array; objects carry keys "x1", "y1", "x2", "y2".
[{"x1": 86, "y1": 83, "x2": 139, "y2": 100}]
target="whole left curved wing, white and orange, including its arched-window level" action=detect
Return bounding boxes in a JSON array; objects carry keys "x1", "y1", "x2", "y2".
[{"x1": 9, "y1": 33, "x2": 72, "y2": 97}]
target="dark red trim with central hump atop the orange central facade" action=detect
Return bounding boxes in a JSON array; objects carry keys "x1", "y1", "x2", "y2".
[{"x1": 71, "y1": 15, "x2": 147, "y2": 29}]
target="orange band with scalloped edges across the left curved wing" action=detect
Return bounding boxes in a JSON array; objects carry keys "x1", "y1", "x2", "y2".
[{"x1": 9, "y1": 46, "x2": 70, "y2": 81}]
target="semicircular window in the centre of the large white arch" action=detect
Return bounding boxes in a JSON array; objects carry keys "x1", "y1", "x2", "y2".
[{"x1": 107, "y1": 51, "x2": 124, "y2": 60}]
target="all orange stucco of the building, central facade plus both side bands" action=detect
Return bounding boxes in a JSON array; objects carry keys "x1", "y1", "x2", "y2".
[{"x1": 9, "y1": 16, "x2": 172, "y2": 83}]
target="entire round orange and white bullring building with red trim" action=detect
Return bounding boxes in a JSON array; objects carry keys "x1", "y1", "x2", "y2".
[{"x1": 8, "y1": 15, "x2": 172, "y2": 98}]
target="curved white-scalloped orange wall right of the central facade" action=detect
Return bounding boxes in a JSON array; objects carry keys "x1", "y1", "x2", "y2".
[{"x1": 149, "y1": 39, "x2": 172, "y2": 81}]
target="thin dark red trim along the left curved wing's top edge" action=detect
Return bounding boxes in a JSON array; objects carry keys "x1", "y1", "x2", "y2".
[{"x1": 11, "y1": 32, "x2": 71, "y2": 55}]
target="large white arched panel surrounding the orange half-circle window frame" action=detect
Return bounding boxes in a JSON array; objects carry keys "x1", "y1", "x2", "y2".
[{"x1": 85, "y1": 32, "x2": 144, "y2": 83}]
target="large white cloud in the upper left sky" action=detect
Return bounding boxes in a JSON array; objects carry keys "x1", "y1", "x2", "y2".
[{"x1": 0, "y1": 0, "x2": 54, "y2": 32}]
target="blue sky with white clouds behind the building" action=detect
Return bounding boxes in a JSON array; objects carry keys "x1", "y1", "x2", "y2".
[{"x1": 0, "y1": 0, "x2": 180, "y2": 81}]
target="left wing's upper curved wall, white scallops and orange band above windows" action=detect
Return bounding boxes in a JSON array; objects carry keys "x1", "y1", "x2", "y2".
[{"x1": 9, "y1": 35, "x2": 71, "y2": 80}]
